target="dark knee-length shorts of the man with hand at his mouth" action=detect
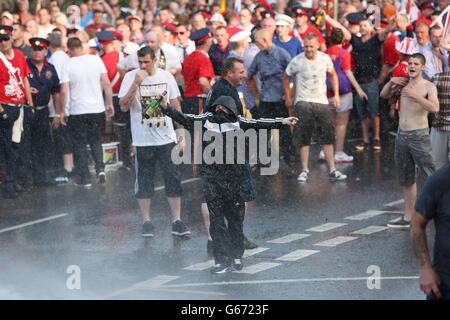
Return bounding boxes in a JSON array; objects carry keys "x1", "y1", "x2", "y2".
[{"x1": 134, "y1": 143, "x2": 182, "y2": 199}]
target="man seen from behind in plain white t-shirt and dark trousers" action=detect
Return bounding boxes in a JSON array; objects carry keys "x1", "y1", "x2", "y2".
[{"x1": 60, "y1": 37, "x2": 114, "y2": 188}]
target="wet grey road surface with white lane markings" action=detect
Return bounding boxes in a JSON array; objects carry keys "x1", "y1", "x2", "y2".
[{"x1": 0, "y1": 137, "x2": 433, "y2": 300}]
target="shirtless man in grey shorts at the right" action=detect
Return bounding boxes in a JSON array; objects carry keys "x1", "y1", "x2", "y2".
[{"x1": 380, "y1": 53, "x2": 439, "y2": 228}]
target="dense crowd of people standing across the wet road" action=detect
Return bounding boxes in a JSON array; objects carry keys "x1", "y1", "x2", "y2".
[{"x1": 0, "y1": 0, "x2": 450, "y2": 296}]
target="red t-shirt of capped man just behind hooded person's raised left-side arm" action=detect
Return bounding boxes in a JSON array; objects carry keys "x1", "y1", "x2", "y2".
[{"x1": 181, "y1": 50, "x2": 214, "y2": 98}]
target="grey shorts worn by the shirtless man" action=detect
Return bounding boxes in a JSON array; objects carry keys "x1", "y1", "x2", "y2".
[{"x1": 395, "y1": 128, "x2": 435, "y2": 187}]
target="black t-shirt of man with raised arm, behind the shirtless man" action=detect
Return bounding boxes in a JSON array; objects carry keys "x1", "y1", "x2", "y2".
[{"x1": 350, "y1": 34, "x2": 382, "y2": 80}]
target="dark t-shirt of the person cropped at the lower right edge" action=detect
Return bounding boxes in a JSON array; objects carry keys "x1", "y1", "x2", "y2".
[{"x1": 415, "y1": 165, "x2": 450, "y2": 286}]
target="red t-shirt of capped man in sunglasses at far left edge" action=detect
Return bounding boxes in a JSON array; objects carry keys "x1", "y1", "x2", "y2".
[{"x1": 0, "y1": 49, "x2": 30, "y2": 104}]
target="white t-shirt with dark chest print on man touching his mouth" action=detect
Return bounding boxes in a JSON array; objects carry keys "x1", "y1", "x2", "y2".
[{"x1": 119, "y1": 68, "x2": 180, "y2": 147}]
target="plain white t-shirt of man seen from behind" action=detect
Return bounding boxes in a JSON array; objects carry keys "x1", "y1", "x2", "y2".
[{"x1": 60, "y1": 54, "x2": 107, "y2": 115}]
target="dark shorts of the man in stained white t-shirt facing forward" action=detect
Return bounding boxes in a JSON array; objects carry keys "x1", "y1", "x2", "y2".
[{"x1": 293, "y1": 101, "x2": 335, "y2": 147}]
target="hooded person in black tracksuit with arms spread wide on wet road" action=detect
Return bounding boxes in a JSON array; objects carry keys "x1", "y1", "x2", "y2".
[{"x1": 163, "y1": 96, "x2": 298, "y2": 274}]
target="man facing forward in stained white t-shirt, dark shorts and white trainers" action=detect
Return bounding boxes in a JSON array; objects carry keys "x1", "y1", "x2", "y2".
[{"x1": 283, "y1": 33, "x2": 347, "y2": 182}]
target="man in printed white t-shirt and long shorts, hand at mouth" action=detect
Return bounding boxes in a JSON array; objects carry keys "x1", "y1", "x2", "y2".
[{"x1": 119, "y1": 47, "x2": 190, "y2": 237}]
